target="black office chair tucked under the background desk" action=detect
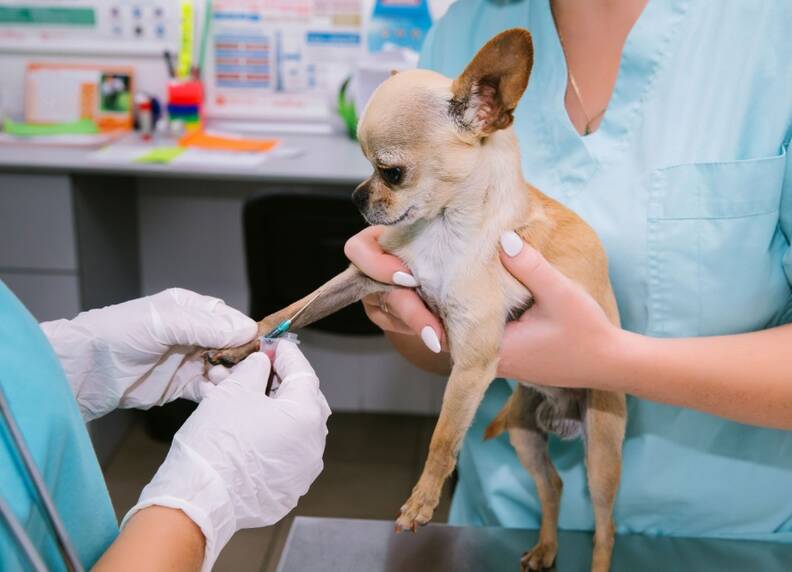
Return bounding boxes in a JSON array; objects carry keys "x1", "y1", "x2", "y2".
[{"x1": 242, "y1": 189, "x2": 382, "y2": 335}]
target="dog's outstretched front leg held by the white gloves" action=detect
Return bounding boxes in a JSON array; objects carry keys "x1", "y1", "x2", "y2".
[{"x1": 206, "y1": 265, "x2": 392, "y2": 365}]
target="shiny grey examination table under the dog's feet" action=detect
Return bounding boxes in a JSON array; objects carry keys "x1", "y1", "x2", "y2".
[{"x1": 277, "y1": 517, "x2": 792, "y2": 572}]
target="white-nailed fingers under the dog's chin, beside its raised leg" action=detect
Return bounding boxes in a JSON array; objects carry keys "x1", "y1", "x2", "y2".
[{"x1": 344, "y1": 226, "x2": 445, "y2": 353}]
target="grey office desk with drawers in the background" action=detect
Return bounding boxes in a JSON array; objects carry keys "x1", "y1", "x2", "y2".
[{"x1": 0, "y1": 135, "x2": 371, "y2": 320}]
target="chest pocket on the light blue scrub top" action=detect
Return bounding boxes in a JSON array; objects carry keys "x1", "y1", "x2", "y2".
[{"x1": 647, "y1": 150, "x2": 790, "y2": 337}]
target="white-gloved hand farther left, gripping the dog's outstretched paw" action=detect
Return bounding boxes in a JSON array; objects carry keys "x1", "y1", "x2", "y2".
[{"x1": 41, "y1": 288, "x2": 257, "y2": 421}]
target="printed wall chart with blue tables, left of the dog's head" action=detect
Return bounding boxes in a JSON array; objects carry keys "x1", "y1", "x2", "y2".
[{"x1": 205, "y1": 0, "x2": 363, "y2": 122}]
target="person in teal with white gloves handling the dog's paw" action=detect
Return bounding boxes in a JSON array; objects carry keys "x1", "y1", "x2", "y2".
[{"x1": 0, "y1": 282, "x2": 330, "y2": 571}]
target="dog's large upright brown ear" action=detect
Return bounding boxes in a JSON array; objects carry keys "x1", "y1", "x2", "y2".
[{"x1": 448, "y1": 28, "x2": 533, "y2": 137}]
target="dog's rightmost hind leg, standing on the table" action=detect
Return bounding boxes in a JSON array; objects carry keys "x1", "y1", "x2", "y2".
[{"x1": 586, "y1": 390, "x2": 627, "y2": 572}]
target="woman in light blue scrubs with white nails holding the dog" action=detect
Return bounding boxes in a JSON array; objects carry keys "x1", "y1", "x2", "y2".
[{"x1": 346, "y1": 0, "x2": 792, "y2": 542}]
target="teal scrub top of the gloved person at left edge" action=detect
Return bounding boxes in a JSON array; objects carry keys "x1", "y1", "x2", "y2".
[{"x1": 0, "y1": 281, "x2": 118, "y2": 571}]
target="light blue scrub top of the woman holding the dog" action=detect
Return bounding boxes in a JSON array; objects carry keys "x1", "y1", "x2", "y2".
[{"x1": 421, "y1": 0, "x2": 792, "y2": 541}]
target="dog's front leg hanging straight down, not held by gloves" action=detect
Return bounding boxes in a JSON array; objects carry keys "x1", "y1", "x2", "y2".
[{"x1": 396, "y1": 315, "x2": 504, "y2": 532}]
